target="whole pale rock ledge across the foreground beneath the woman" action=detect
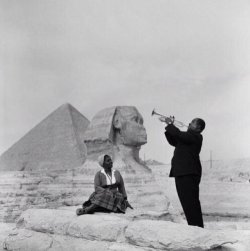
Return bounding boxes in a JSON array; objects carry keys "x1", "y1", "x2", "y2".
[{"x1": 4, "y1": 209, "x2": 239, "y2": 251}]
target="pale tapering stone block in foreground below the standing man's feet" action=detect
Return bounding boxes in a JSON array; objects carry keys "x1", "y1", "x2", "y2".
[{"x1": 125, "y1": 220, "x2": 237, "y2": 251}]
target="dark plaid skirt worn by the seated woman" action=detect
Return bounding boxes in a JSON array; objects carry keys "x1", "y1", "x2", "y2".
[{"x1": 83, "y1": 189, "x2": 126, "y2": 213}]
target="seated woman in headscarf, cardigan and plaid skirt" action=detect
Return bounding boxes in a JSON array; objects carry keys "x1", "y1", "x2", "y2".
[{"x1": 76, "y1": 155, "x2": 133, "y2": 215}]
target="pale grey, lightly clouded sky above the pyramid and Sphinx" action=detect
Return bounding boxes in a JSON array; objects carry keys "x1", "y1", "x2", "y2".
[{"x1": 0, "y1": 0, "x2": 250, "y2": 163}]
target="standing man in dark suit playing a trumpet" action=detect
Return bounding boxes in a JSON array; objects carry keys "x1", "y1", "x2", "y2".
[{"x1": 161, "y1": 117, "x2": 205, "y2": 228}]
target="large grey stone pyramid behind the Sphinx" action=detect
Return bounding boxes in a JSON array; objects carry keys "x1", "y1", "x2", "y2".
[{"x1": 0, "y1": 104, "x2": 89, "y2": 171}]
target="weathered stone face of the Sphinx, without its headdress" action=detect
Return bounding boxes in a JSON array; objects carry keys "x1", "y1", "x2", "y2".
[{"x1": 113, "y1": 107, "x2": 147, "y2": 146}]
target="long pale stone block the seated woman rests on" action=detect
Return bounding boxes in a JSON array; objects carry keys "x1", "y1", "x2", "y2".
[{"x1": 17, "y1": 209, "x2": 129, "y2": 241}]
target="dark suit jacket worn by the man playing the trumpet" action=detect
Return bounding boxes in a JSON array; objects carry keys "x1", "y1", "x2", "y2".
[{"x1": 165, "y1": 124, "x2": 203, "y2": 177}]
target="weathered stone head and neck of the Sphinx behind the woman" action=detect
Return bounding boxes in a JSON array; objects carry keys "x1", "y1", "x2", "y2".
[{"x1": 84, "y1": 106, "x2": 151, "y2": 173}]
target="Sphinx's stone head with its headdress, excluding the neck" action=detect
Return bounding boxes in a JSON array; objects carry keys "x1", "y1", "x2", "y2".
[{"x1": 84, "y1": 106, "x2": 147, "y2": 158}]
